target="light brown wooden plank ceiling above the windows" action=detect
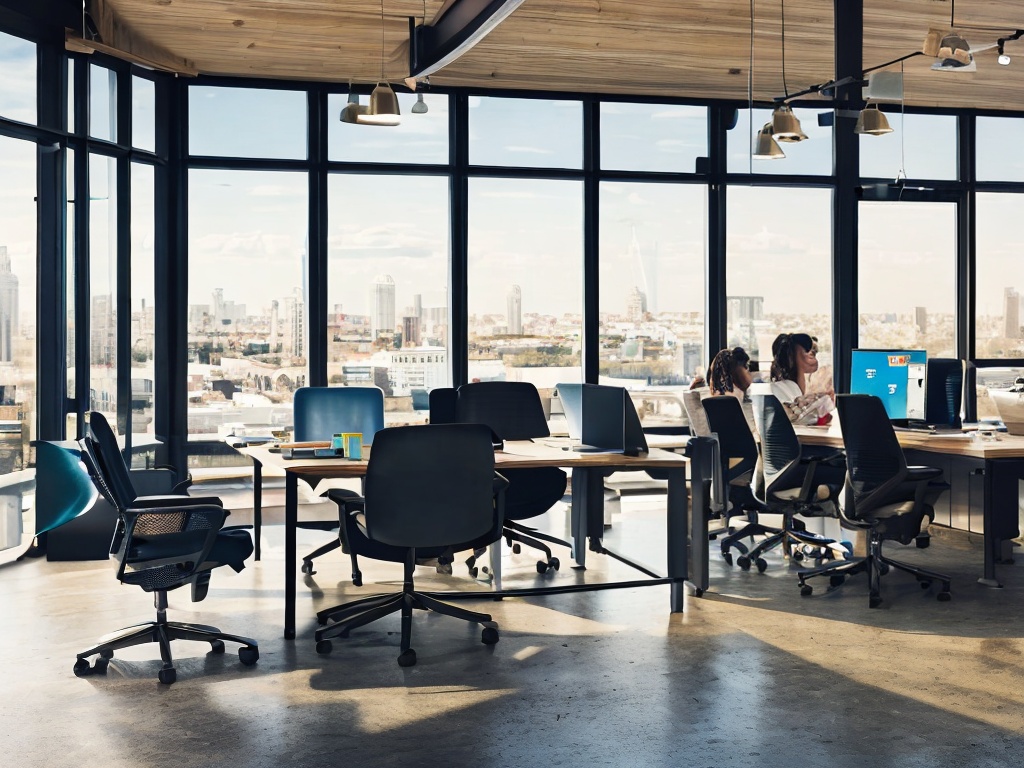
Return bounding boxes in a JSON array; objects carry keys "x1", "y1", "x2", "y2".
[{"x1": 75, "y1": 0, "x2": 1024, "y2": 109}]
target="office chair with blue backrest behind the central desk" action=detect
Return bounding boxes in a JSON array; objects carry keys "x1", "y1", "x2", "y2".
[{"x1": 292, "y1": 387, "x2": 384, "y2": 574}]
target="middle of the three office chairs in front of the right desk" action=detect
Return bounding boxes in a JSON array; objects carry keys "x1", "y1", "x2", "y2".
[{"x1": 733, "y1": 394, "x2": 846, "y2": 572}]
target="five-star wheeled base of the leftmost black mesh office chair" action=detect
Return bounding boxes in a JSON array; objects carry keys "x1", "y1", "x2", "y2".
[{"x1": 74, "y1": 592, "x2": 259, "y2": 685}]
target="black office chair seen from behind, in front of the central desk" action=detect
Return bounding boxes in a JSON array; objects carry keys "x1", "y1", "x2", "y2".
[{"x1": 315, "y1": 424, "x2": 508, "y2": 667}]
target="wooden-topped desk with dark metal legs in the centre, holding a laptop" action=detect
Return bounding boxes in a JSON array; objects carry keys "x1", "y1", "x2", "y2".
[{"x1": 239, "y1": 441, "x2": 692, "y2": 639}]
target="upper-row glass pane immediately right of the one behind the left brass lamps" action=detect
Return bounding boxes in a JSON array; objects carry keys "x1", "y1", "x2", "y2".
[{"x1": 469, "y1": 96, "x2": 583, "y2": 168}]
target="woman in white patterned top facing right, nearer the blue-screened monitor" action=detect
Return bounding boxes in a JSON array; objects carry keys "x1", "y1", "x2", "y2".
[{"x1": 771, "y1": 334, "x2": 835, "y2": 424}]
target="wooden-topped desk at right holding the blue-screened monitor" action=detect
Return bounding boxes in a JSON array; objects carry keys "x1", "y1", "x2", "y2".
[{"x1": 796, "y1": 424, "x2": 1024, "y2": 587}]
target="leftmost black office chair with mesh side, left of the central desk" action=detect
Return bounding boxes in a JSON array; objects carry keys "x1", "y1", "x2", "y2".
[{"x1": 70, "y1": 413, "x2": 259, "y2": 685}]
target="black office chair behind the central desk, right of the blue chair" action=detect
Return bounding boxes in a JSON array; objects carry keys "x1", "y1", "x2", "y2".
[{"x1": 452, "y1": 381, "x2": 572, "y2": 573}]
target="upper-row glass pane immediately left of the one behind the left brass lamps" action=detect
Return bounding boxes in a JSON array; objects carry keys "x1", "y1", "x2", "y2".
[{"x1": 188, "y1": 86, "x2": 305, "y2": 160}]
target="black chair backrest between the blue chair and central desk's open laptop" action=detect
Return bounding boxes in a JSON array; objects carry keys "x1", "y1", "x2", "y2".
[{"x1": 456, "y1": 381, "x2": 551, "y2": 440}]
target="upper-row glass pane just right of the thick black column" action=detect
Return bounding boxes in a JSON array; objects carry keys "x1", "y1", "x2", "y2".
[{"x1": 860, "y1": 113, "x2": 956, "y2": 179}]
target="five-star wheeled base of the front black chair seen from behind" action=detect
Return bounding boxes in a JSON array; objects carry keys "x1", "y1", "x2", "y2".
[{"x1": 314, "y1": 550, "x2": 500, "y2": 667}]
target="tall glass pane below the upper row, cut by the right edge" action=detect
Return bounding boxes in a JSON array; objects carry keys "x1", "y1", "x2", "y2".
[{"x1": 974, "y1": 193, "x2": 1024, "y2": 357}]
